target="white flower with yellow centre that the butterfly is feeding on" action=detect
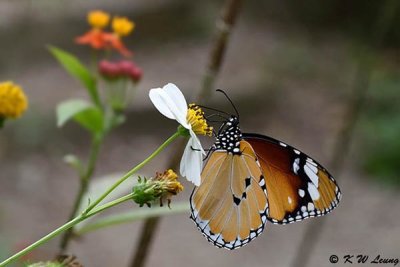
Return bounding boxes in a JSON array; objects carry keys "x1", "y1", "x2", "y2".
[{"x1": 149, "y1": 83, "x2": 212, "y2": 186}]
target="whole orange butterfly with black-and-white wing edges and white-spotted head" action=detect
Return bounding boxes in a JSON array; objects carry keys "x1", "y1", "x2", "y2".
[{"x1": 190, "y1": 90, "x2": 341, "y2": 250}]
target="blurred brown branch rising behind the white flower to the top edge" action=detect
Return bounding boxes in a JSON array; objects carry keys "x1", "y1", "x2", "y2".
[{"x1": 130, "y1": 0, "x2": 242, "y2": 267}]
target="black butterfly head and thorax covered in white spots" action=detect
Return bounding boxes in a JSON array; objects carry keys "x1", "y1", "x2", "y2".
[{"x1": 214, "y1": 115, "x2": 242, "y2": 154}]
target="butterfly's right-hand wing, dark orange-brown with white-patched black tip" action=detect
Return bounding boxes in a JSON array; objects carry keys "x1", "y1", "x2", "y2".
[{"x1": 243, "y1": 134, "x2": 341, "y2": 224}]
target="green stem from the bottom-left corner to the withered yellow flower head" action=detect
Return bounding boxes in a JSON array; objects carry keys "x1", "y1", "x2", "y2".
[{"x1": 0, "y1": 193, "x2": 134, "y2": 266}]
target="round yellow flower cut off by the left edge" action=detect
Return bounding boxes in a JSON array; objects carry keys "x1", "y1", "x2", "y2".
[{"x1": 0, "y1": 81, "x2": 28, "y2": 119}]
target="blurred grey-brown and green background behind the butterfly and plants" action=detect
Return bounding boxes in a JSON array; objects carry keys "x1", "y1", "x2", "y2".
[{"x1": 0, "y1": 0, "x2": 400, "y2": 266}]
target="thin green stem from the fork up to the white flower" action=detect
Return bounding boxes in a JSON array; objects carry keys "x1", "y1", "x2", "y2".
[{"x1": 83, "y1": 132, "x2": 181, "y2": 214}]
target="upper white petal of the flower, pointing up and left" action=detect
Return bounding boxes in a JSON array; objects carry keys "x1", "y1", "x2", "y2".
[{"x1": 149, "y1": 85, "x2": 190, "y2": 129}]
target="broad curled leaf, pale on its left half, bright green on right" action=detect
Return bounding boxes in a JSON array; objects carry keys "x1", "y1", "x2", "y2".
[{"x1": 57, "y1": 99, "x2": 104, "y2": 134}]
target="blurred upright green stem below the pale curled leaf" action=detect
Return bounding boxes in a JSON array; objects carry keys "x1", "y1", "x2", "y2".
[{"x1": 59, "y1": 136, "x2": 103, "y2": 254}]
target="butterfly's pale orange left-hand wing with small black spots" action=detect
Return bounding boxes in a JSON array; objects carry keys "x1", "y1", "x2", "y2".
[{"x1": 191, "y1": 141, "x2": 268, "y2": 249}]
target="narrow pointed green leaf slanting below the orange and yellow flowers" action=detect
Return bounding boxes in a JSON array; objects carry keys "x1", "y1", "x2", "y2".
[{"x1": 48, "y1": 46, "x2": 100, "y2": 105}]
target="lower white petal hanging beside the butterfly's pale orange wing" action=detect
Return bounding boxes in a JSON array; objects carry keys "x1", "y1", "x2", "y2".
[{"x1": 180, "y1": 138, "x2": 203, "y2": 186}]
